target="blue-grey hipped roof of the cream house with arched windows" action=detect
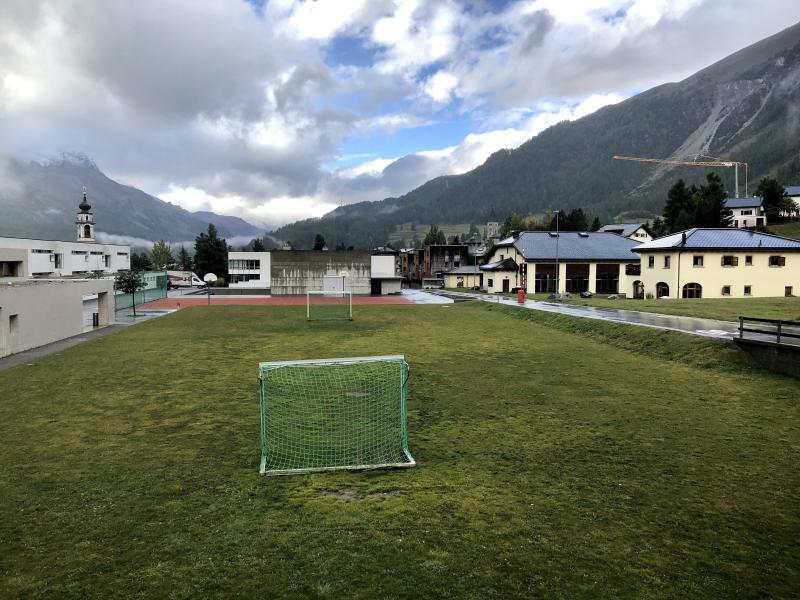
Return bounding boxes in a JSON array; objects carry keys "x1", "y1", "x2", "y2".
[{"x1": 635, "y1": 227, "x2": 800, "y2": 252}]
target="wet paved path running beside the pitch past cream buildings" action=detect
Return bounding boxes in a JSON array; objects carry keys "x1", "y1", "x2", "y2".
[{"x1": 436, "y1": 291, "x2": 800, "y2": 344}]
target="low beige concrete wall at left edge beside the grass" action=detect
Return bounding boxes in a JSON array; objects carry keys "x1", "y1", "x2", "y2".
[{"x1": 0, "y1": 279, "x2": 114, "y2": 356}]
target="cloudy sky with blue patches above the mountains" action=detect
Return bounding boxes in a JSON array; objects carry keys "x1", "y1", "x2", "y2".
[{"x1": 0, "y1": 0, "x2": 800, "y2": 232}]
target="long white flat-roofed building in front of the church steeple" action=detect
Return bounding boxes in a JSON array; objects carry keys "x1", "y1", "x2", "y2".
[{"x1": 0, "y1": 238, "x2": 131, "y2": 277}]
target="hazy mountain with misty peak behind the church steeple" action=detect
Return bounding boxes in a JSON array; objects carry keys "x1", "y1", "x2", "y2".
[{"x1": 0, "y1": 154, "x2": 263, "y2": 243}]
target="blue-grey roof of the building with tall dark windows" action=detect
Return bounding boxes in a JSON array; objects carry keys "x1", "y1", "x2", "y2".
[{"x1": 514, "y1": 231, "x2": 639, "y2": 260}]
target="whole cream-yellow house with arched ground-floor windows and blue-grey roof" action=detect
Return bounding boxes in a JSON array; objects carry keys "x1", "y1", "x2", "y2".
[{"x1": 633, "y1": 228, "x2": 800, "y2": 298}]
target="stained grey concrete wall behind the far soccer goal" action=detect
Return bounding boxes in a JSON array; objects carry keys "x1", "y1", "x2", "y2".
[{"x1": 271, "y1": 250, "x2": 371, "y2": 296}]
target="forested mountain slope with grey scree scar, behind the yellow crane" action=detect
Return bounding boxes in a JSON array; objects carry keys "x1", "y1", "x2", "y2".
[{"x1": 273, "y1": 24, "x2": 800, "y2": 247}]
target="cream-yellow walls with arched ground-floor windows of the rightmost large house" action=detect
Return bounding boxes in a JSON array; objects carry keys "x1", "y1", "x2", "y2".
[{"x1": 641, "y1": 249, "x2": 800, "y2": 298}]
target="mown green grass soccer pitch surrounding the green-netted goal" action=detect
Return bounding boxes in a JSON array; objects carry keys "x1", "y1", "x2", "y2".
[{"x1": 0, "y1": 303, "x2": 800, "y2": 598}]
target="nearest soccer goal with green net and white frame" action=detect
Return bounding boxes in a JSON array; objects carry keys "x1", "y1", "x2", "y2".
[{"x1": 259, "y1": 356, "x2": 416, "y2": 475}]
